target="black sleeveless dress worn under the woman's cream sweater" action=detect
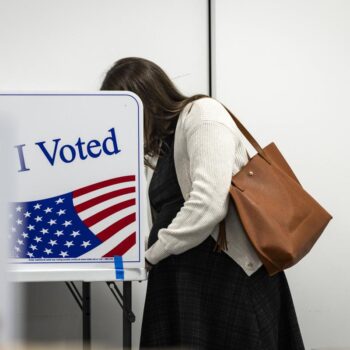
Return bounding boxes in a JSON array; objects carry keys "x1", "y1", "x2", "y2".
[{"x1": 140, "y1": 129, "x2": 305, "y2": 350}]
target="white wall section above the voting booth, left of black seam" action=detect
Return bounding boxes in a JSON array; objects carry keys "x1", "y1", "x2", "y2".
[{"x1": 0, "y1": 0, "x2": 208, "y2": 93}]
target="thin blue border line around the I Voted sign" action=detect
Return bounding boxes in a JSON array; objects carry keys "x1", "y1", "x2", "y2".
[{"x1": 0, "y1": 90, "x2": 142, "y2": 265}]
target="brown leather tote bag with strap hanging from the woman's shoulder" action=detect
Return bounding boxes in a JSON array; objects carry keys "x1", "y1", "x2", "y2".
[{"x1": 215, "y1": 106, "x2": 333, "y2": 276}]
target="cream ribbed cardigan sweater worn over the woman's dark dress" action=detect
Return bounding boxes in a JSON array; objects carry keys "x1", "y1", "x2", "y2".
[{"x1": 145, "y1": 97, "x2": 262, "y2": 276}]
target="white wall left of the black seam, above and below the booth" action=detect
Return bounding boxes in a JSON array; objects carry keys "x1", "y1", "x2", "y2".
[{"x1": 0, "y1": 0, "x2": 208, "y2": 349}]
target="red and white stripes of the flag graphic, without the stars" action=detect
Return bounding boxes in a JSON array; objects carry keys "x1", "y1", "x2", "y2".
[{"x1": 73, "y1": 175, "x2": 136, "y2": 258}]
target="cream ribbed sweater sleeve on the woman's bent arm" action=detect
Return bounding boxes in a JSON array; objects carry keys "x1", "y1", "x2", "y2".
[{"x1": 145, "y1": 120, "x2": 238, "y2": 264}]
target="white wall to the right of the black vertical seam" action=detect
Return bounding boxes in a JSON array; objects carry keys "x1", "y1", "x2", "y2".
[{"x1": 214, "y1": 0, "x2": 350, "y2": 349}]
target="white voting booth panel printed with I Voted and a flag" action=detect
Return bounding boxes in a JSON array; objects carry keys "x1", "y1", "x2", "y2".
[{"x1": 0, "y1": 91, "x2": 148, "y2": 282}]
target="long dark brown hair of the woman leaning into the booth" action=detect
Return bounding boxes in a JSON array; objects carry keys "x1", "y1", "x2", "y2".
[{"x1": 100, "y1": 57, "x2": 209, "y2": 169}]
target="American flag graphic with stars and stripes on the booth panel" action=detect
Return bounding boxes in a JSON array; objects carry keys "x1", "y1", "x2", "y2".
[{"x1": 9, "y1": 175, "x2": 136, "y2": 260}]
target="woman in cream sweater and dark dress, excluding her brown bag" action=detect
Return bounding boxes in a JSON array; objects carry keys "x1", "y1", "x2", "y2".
[{"x1": 101, "y1": 57, "x2": 304, "y2": 350}]
